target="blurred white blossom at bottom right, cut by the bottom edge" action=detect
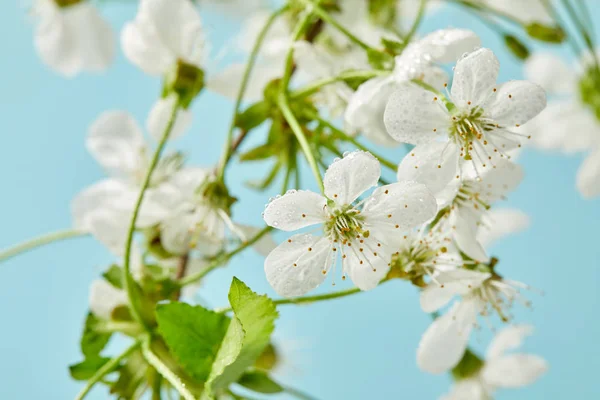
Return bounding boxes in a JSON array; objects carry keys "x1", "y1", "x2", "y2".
[{"x1": 441, "y1": 325, "x2": 548, "y2": 400}]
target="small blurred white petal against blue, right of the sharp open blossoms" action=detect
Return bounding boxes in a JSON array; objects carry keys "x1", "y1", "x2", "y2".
[{"x1": 477, "y1": 208, "x2": 530, "y2": 249}]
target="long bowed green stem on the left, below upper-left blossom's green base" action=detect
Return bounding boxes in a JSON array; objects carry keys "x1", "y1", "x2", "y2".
[{"x1": 123, "y1": 101, "x2": 179, "y2": 330}]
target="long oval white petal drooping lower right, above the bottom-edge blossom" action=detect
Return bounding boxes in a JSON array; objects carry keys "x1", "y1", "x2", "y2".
[{"x1": 417, "y1": 300, "x2": 477, "y2": 374}]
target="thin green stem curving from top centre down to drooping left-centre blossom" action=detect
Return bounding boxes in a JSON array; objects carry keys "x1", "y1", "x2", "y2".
[{"x1": 217, "y1": 5, "x2": 288, "y2": 180}]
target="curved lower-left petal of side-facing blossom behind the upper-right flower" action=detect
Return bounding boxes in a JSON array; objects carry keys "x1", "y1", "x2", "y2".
[{"x1": 344, "y1": 77, "x2": 398, "y2": 146}]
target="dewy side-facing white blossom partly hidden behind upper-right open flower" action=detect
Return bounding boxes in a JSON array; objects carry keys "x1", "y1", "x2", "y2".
[{"x1": 344, "y1": 29, "x2": 480, "y2": 146}]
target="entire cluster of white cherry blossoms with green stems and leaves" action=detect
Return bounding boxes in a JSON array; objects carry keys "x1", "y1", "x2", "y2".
[{"x1": 7, "y1": 0, "x2": 600, "y2": 400}]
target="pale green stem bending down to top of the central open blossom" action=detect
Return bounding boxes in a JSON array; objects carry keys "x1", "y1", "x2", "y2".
[{"x1": 277, "y1": 14, "x2": 324, "y2": 192}]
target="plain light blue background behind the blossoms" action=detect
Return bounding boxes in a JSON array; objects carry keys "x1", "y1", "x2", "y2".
[{"x1": 0, "y1": 1, "x2": 600, "y2": 400}]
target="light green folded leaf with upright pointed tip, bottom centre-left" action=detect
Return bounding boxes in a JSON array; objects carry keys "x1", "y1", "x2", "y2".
[{"x1": 203, "y1": 277, "x2": 277, "y2": 398}]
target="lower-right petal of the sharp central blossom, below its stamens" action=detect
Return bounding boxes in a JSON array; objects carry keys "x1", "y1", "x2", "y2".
[{"x1": 342, "y1": 237, "x2": 391, "y2": 290}]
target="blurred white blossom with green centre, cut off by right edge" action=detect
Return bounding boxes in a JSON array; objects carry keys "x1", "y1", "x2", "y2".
[{"x1": 524, "y1": 53, "x2": 600, "y2": 198}]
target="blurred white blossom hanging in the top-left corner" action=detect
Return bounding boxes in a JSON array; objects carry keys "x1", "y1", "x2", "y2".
[{"x1": 34, "y1": 0, "x2": 115, "y2": 77}]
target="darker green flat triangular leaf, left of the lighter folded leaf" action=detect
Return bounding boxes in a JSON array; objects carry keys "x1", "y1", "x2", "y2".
[{"x1": 156, "y1": 303, "x2": 229, "y2": 382}]
